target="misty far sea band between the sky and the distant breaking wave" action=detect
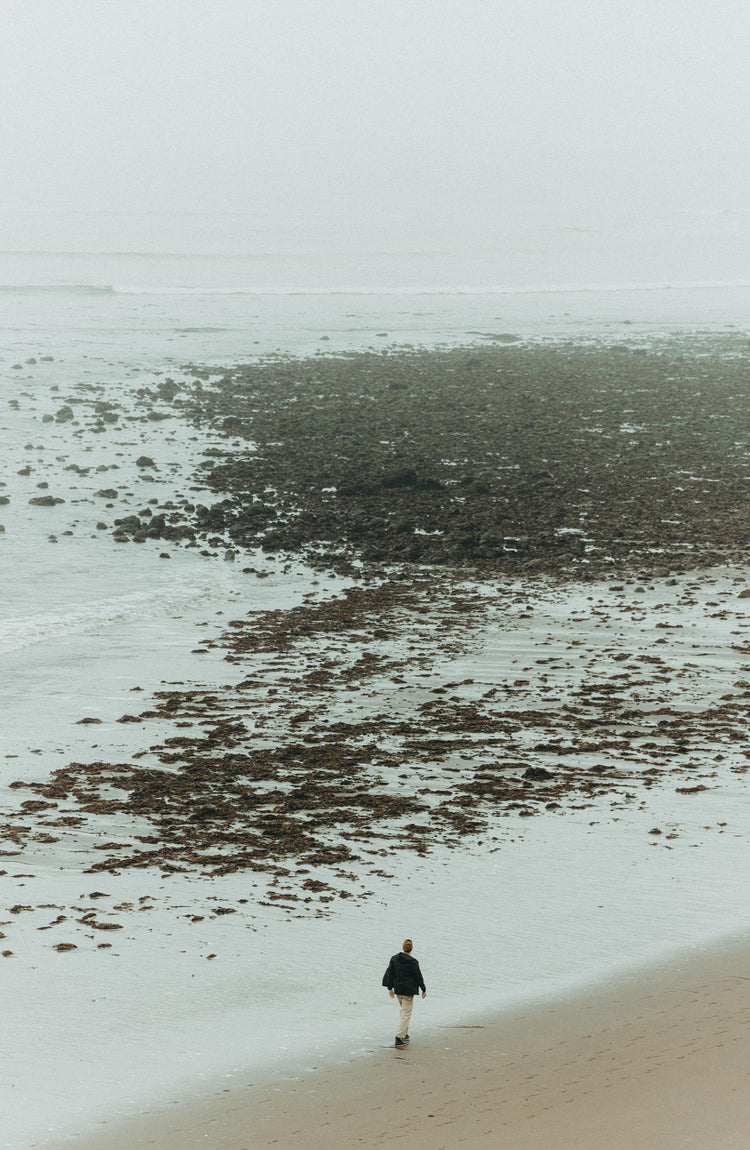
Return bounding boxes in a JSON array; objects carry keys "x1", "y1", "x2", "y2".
[{"x1": 0, "y1": 202, "x2": 750, "y2": 289}]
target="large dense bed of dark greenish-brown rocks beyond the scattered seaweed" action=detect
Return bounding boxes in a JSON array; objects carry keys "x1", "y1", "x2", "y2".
[{"x1": 151, "y1": 337, "x2": 750, "y2": 576}]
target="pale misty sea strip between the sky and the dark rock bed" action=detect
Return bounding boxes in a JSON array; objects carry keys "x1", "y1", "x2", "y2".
[{"x1": 0, "y1": 210, "x2": 750, "y2": 370}]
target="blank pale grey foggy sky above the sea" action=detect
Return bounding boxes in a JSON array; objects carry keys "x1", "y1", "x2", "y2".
[{"x1": 0, "y1": 0, "x2": 750, "y2": 227}]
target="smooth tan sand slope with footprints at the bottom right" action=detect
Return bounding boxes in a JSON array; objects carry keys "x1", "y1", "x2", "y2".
[{"x1": 66, "y1": 940, "x2": 750, "y2": 1150}]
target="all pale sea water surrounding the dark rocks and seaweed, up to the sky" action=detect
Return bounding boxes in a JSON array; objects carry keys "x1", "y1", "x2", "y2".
[{"x1": 0, "y1": 212, "x2": 750, "y2": 1150}]
